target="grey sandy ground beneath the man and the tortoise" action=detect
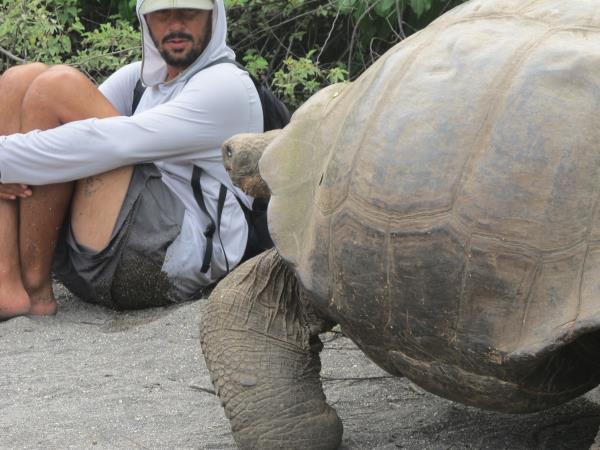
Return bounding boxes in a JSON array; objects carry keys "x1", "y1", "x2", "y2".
[{"x1": 0, "y1": 286, "x2": 600, "y2": 450}]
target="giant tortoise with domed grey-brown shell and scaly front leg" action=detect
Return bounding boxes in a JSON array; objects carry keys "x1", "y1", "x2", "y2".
[{"x1": 201, "y1": 0, "x2": 600, "y2": 449}]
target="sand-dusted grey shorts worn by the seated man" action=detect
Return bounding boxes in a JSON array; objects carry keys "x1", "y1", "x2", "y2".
[{"x1": 53, "y1": 164, "x2": 185, "y2": 309}]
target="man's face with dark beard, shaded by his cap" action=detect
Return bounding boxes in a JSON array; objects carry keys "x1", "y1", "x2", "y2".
[{"x1": 145, "y1": 9, "x2": 212, "y2": 69}]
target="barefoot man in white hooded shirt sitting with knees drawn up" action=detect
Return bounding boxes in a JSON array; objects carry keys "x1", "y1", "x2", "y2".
[{"x1": 0, "y1": 0, "x2": 263, "y2": 319}]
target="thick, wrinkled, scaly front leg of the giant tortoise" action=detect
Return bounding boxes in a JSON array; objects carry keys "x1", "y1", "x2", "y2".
[{"x1": 200, "y1": 250, "x2": 342, "y2": 449}]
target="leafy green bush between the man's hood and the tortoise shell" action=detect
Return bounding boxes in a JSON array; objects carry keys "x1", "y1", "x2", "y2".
[{"x1": 225, "y1": 0, "x2": 463, "y2": 107}]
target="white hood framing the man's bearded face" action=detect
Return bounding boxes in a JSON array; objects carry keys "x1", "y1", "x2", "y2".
[{"x1": 136, "y1": 0, "x2": 235, "y2": 86}]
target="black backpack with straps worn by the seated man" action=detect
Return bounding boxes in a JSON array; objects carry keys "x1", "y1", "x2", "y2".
[{"x1": 131, "y1": 58, "x2": 290, "y2": 273}]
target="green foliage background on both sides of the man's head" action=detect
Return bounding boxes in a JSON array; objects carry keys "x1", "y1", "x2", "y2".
[{"x1": 0, "y1": 0, "x2": 464, "y2": 108}]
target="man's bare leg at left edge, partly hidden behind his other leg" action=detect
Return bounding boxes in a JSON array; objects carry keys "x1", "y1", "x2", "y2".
[{"x1": 0, "y1": 64, "x2": 48, "y2": 320}]
